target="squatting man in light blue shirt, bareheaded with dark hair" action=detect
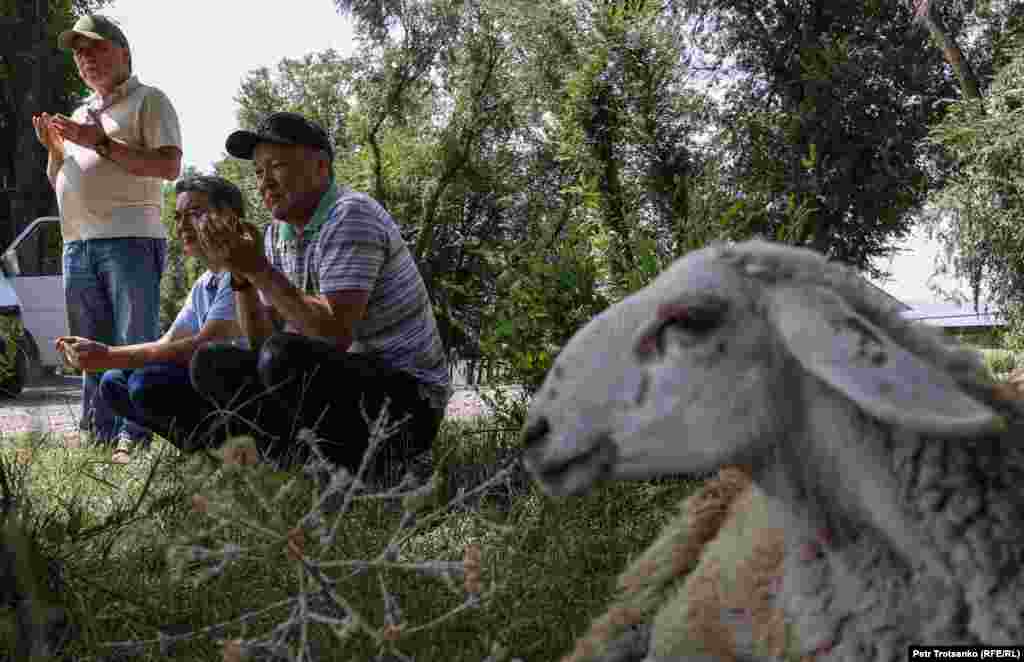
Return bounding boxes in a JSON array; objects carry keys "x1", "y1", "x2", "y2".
[{"x1": 57, "y1": 175, "x2": 247, "y2": 462}]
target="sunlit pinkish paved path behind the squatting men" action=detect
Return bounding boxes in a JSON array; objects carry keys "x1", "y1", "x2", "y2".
[{"x1": 0, "y1": 376, "x2": 507, "y2": 444}]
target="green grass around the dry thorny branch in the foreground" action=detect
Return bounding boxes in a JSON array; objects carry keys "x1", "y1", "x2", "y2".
[{"x1": 0, "y1": 411, "x2": 695, "y2": 662}]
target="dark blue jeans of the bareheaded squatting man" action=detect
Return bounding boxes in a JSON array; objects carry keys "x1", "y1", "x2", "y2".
[{"x1": 98, "y1": 363, "x2": 220, "y2": 451}]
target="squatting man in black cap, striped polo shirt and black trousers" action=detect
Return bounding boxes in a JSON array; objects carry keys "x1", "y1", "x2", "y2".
[{"x1": 191, "y1": 113, "x2": 451, "y2": 477}]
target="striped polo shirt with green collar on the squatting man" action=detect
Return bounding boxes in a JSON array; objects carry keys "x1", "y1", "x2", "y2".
[{"x1": 263, "y1": 183, "x2": 451, "y2": 409}]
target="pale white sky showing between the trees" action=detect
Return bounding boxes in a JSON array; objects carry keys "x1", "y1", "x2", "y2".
[{"x1": 94, "y1": 0, "x2": 967, "y2": 304}]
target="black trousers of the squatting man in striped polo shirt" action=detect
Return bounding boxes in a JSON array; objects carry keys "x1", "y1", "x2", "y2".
[{"x1": 189, "y1": 333, "x2": 444, "y2": 475}]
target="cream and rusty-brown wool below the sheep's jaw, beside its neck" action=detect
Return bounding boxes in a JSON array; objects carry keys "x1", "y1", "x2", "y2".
[{"x1": 563, "y1": 467, "x2": 813, "y2": 662}]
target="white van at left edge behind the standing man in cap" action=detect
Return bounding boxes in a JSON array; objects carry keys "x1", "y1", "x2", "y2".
[{"x1": 0, "y1": 216, "x2": 68, "y2": 398}]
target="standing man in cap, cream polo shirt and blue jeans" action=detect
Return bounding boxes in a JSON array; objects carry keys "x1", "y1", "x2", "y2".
[{"x1": 33, "y1": 15, "x2": 181, "y2": 448}]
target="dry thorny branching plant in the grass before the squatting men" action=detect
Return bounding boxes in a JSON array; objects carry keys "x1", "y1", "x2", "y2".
[{"x1": 99, "y1": 400, "x2": 515, "y2": 662}]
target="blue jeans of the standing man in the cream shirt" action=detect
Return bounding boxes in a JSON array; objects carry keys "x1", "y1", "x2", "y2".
[{"x1": 63, "y1": 237, "x2": 167, "y2": 443}]
